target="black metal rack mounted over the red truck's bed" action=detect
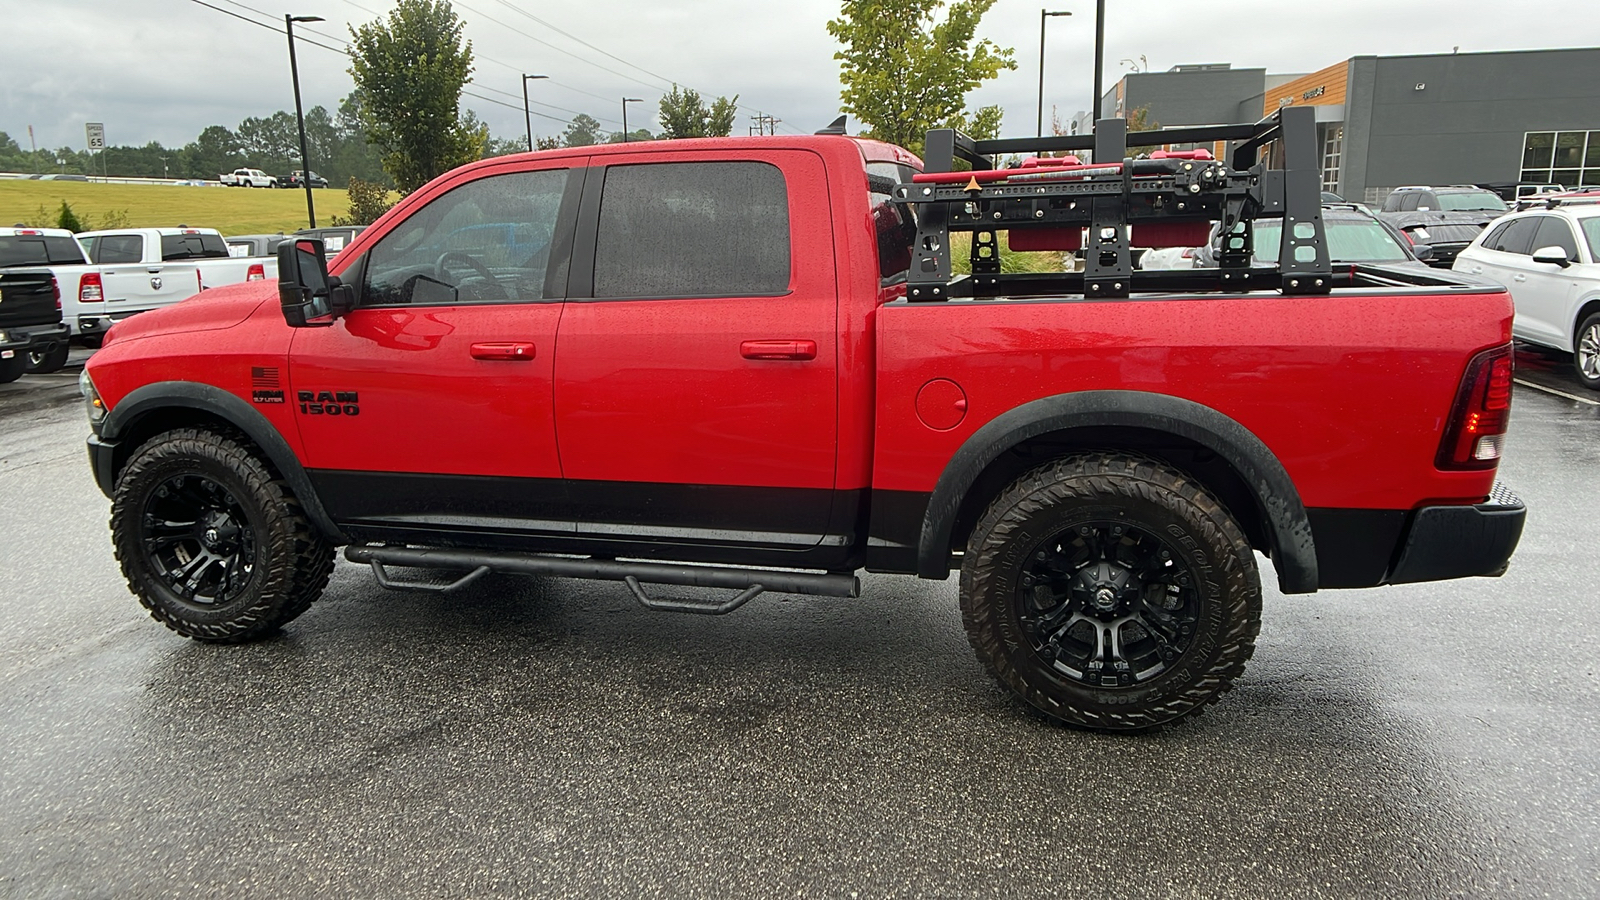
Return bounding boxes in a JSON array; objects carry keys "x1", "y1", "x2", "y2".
[{"x1": 893, "y1": 107, "x2": 1333, "y2": 301}]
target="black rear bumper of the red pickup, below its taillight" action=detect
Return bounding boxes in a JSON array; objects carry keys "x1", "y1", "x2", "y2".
[{"x1": 1389, "y1": 482, "x2": 1528, "y2": 585}]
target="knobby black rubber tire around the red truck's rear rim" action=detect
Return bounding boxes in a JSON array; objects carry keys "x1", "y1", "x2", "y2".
[{"x1": 962, "y1": 453, "x2": 1261, "y2": 732}]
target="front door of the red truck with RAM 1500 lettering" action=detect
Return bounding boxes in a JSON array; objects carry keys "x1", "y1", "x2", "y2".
[{"x1": 288, "y1": 160, "x2": 581, "y2": 540}]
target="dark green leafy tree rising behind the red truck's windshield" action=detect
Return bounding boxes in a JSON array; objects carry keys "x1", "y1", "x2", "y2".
[{"x1": 349, "y1": 0, "x2": 488, "y2": 194}]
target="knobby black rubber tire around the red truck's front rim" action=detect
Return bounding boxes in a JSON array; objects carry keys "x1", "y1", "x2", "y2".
[{"x1": 110, "y1": 428, "x2": 334, "y2": 644}]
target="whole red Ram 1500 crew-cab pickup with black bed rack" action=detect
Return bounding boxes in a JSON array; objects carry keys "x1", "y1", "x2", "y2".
[{"x1": 83, "y1": 107, "x2": 1525, "y2": 730}]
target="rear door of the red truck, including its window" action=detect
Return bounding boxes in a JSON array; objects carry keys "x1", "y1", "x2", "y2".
[{"x1": 555, "y1": 149, "x2": 842, "y2": 551}]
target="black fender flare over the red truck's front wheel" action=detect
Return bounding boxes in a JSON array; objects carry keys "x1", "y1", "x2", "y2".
[{"x1": 99, "y1": 381, "x2": 350, "y2": 544}]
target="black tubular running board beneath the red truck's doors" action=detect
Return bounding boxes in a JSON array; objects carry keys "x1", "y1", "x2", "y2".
[{"x1": 344, "y1": 544, "x2": 861, "y2": 615}]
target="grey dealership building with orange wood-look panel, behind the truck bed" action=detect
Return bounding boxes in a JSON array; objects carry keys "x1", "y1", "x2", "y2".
[{"x1": 1070, "y1": 48, "x2": 1600, "y2": 203}]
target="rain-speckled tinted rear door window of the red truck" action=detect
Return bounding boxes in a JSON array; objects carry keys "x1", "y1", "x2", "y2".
[{"x1": 594, "y1": 162, "x2": 789, "y2": 298}]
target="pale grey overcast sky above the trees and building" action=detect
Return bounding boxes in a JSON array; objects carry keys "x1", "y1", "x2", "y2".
[{"x1": 9, "y1": 0, "x2": 1600, "y2": 149}]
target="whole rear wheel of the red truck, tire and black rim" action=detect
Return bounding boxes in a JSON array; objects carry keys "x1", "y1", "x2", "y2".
[{"x1": 962, "y1": 453, "x2": 1261, "y2": 732}]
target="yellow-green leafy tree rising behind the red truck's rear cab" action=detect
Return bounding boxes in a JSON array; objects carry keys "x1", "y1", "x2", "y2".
[{"x1": 827, "y1": 0, "x2": 1016, "y2": 154}]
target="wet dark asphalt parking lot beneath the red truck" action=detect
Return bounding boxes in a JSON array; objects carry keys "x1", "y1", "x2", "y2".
[{"x1": 0, "y1": 344, "x2": 1600, "y2": 898}]
